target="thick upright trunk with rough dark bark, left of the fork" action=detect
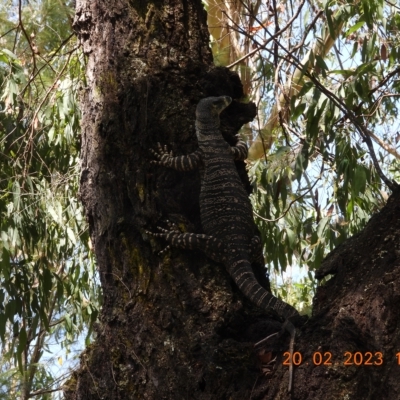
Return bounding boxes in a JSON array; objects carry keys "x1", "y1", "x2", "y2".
[{"x1": 65, "y1": 0, "x2": 277, "y2": 399}]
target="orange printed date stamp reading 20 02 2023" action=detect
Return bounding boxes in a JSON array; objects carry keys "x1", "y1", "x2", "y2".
[{"x1": 282, "y1": 351, "x2": 388, "y2": 367}]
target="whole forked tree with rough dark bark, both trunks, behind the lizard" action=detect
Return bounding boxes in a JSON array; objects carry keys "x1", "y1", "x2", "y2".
[{"x1": 64, "y1": 0, "x2": 400, "y2": 400}]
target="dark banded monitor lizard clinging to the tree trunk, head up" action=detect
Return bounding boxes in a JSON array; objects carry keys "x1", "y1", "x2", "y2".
[{"x1": 148, "y1": 96, "x2": 299, "y2": 389}]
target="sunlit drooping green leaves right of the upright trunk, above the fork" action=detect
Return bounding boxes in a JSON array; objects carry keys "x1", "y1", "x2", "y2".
[{"x1": 214, "y1": 0, "x2": 400, "y2": 306}]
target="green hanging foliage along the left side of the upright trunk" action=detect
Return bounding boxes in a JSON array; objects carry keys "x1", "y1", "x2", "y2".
[{"x1": 0, "y1": 0, "x2": 100, "y2": 399}]
